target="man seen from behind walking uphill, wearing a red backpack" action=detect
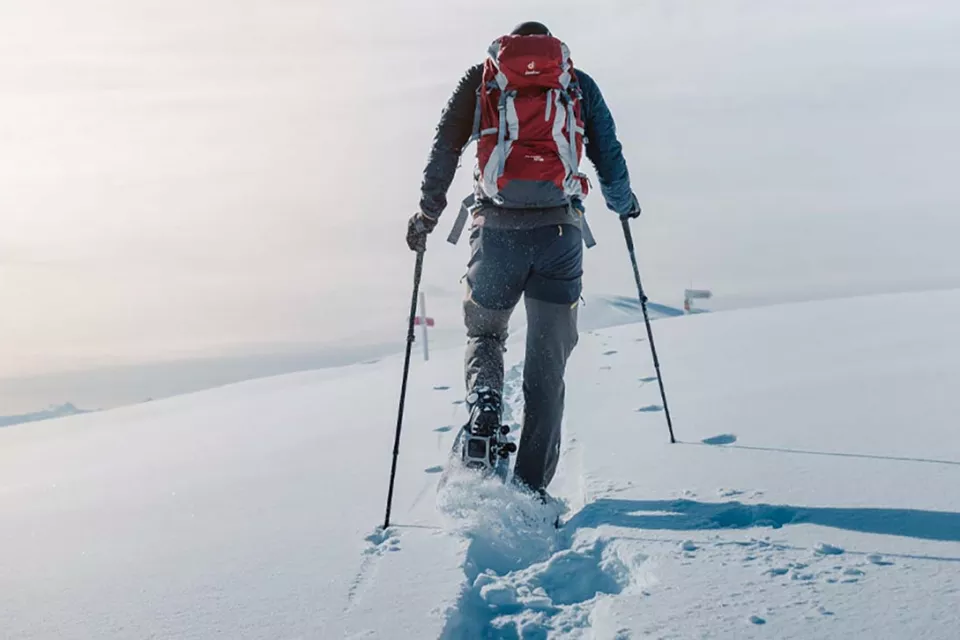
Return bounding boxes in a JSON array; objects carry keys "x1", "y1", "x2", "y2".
[{"x1": 407, "y1": 22, "x2": 640, "y2": 495}]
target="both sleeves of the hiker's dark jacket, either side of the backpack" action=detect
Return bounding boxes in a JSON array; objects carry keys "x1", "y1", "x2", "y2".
[{"x1": 420, "y1": 64, "x2": 639, "y2": 218}]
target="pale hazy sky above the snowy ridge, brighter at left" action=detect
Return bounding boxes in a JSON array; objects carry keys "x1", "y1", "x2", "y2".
[{"x1": 0, "y1": 0, "x2": 960, "y2": 377}]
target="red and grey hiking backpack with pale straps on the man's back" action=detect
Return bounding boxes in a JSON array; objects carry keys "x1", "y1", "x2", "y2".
[{"x1": 474, "y1": 35, "x2": 589, "y2": 209}]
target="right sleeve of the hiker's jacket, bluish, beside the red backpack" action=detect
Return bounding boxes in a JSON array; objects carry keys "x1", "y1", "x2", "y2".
[{"x1": 577, "y1": 69, "x2": 640, "y2": 215}]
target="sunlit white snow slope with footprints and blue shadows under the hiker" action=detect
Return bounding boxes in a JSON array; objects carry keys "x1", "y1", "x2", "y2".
[{"x1": 0, "y1": 291, "x2": 960, "y2": 639}]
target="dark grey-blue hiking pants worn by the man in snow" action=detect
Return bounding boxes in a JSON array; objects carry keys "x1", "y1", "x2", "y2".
[{"x1": 463, "y1": 224, "x2": 583, "y2": 489}]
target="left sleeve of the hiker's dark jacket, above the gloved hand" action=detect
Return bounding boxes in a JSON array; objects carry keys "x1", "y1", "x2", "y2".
[{"x1": 420, "y1": 65, "x2": 483, "y2": 218}]
